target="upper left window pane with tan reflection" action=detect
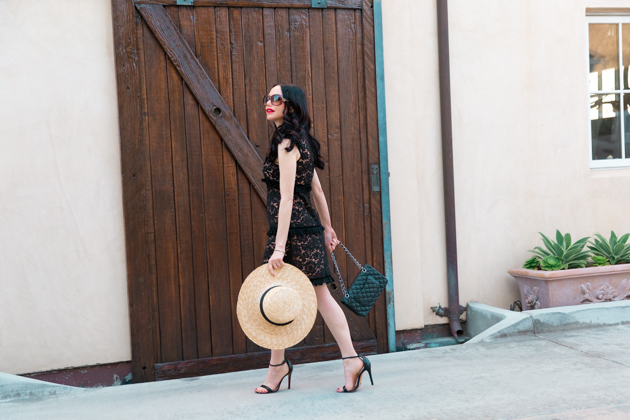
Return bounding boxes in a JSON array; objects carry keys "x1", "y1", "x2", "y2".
[{"x1": 588, "y1": 23, "x2": 619, "y2": 92}]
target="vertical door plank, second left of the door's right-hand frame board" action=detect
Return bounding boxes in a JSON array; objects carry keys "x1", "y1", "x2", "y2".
[{"x1": 322, "y1": 10, "x2": 347, "y2": 343}]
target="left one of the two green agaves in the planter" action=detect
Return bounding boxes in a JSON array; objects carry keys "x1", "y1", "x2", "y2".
[{"x1": 528, "y1": 229, "x2": 591, "y2": 271}]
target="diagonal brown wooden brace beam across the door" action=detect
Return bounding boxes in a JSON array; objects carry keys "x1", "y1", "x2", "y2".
[{"x1": 136, "y1": 4, "x2": 266, "y2": 201}]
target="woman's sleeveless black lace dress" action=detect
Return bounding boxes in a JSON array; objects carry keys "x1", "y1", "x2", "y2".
[{"x1": 263, "y1": 139, "x2": 334, "y2": 286}]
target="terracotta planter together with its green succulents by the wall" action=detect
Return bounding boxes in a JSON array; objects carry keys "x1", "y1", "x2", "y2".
[{"x1": 508, "y1": 230, "x2": 630, "y2": 310}]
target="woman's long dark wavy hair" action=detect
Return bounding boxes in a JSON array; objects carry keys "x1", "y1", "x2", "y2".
[{"x1": 265, "y1": 85, "x2": 324, "y2": 169}]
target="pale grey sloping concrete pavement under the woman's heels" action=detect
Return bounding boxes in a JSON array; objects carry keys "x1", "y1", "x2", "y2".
[{"x1": 0, "y1": 304, "x2": 630, "y2": 420}]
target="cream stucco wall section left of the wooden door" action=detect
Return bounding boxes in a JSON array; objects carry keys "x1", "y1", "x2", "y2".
[{"x1": 0, "y1": 0, "x2": 131, "y2": 373}]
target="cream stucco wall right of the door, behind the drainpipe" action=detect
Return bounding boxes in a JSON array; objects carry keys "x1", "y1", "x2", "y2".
[{"x1": 383, "y1": 0, "x2": 630, "y2": 330}]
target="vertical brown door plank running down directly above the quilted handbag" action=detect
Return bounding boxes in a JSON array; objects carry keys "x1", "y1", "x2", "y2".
[{"x1": 335, "y1": 10, "x2": 365, "y2": 284}]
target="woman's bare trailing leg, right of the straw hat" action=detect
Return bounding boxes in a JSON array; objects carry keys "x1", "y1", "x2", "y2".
[{"x1": 315, "y1": 285, "x2": 363, "y2": 392}]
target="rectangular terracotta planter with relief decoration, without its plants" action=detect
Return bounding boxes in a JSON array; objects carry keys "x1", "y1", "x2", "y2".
[{"x1": 508, "y1": 264, "x2": 630, "y2": 311}]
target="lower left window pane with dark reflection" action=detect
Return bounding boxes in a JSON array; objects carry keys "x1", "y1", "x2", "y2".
[{"x1": 591, "y1": 95, "x2": 630, "y2": 160}]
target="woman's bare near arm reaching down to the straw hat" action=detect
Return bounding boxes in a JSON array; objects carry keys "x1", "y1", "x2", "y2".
[{"x1": 268, "y1": 139, "x2": 300, "y2": 275}]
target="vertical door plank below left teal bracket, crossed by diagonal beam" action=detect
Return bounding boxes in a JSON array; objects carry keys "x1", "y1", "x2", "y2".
[{"x1": 179, "y1": 7, "x2": 212, "y2": 357}]
